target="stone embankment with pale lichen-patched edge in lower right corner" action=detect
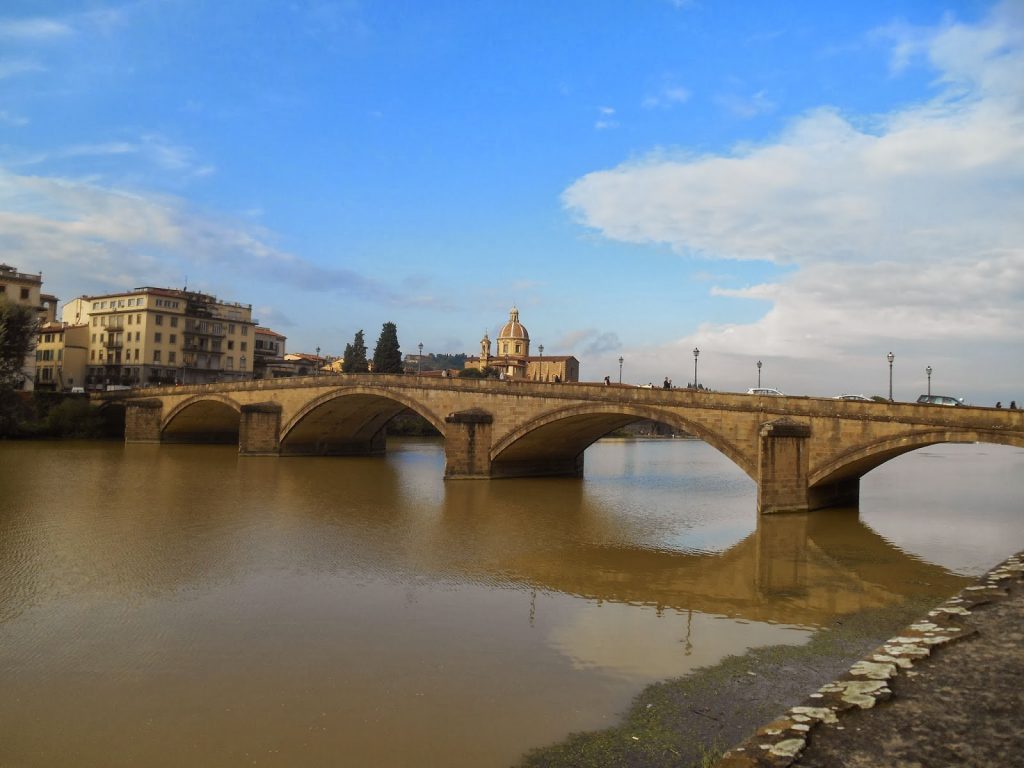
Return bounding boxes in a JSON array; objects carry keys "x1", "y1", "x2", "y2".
[{"x1": 715, "y1": 552, "x2": 1024, "y2": 768}]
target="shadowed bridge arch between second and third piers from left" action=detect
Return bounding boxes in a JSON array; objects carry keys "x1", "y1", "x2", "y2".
[{"x1": 281, "y1": 385, "x2": 445, "y2": 455}]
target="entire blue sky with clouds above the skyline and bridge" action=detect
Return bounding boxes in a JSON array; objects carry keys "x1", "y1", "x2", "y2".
[{"x1": 0, "y1": 0, "x2": 1024, "y2": 404}]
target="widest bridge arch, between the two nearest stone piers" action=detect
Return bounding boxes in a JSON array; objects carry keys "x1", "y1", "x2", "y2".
[{"x1": 490, "y1": 402, "x2": 757, "y2": 481}]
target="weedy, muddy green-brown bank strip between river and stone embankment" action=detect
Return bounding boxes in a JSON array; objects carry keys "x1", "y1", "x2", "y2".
[{"x1": 520, "y1": 599, "x2": 934, "y2": 768}]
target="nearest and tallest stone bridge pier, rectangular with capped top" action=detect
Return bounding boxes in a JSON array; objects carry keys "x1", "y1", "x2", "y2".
[{"x1": 758, "y1": 419, "x2": 811, "y2": 515}]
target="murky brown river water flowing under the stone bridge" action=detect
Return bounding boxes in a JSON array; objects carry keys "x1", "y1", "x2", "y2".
[{"x1": 0, "y1": 439, "x2": 1024, "y2": 767}]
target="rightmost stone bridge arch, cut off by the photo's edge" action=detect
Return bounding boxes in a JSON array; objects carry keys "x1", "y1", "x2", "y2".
[{"x1": 808, "y1": 430, "x2": 1024, "y2": 488}]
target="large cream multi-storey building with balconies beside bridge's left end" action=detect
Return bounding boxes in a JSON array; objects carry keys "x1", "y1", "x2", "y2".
[{"x1": 61, "y1": 288, "x2": 257, "y2": 389}]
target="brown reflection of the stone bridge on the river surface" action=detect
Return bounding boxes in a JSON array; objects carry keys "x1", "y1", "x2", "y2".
[{"x1": 438, "y1": 481, "x2": 969, "y2": 626}]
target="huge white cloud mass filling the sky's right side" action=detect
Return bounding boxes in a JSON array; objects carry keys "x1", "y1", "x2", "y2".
[{"x1": 563, "y1": 3, "x2": 1024, "y2": 399}]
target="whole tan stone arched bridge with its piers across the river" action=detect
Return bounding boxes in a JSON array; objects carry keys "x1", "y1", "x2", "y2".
[{"x1": 100, "y1": 374, "x2": 1024, "y2": 513}]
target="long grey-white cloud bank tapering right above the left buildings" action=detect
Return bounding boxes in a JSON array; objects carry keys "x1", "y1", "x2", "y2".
[{"x1": 0, "y1": 169, "x2": 415, "y2": 305}]
